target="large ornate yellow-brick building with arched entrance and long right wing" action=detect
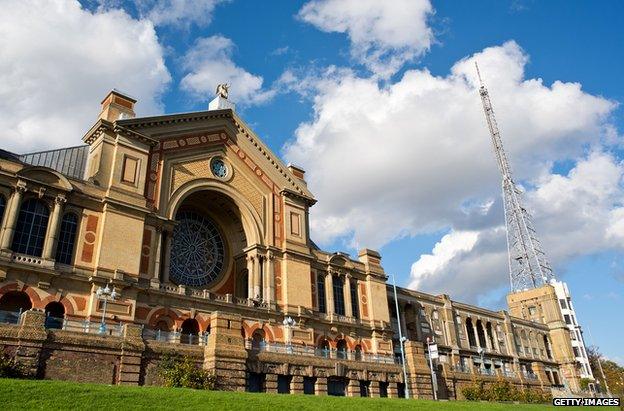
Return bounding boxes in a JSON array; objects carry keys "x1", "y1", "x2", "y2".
[{"x1": 0, "y1": 90, "x2": 578, "y2": 398}]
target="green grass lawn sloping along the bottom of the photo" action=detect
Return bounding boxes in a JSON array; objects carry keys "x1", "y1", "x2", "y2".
[{"x1": 0, "y1": 379, "x2": 604, "y2": 411}]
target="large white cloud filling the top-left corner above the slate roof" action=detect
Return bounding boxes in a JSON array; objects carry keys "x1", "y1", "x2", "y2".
[{"x1": 0, "y1": 0, "x2": 170, "y2": 152}]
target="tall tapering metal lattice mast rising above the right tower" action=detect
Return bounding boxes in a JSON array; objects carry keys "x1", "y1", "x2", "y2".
[{"x1": 475, "y1": 63, "x2": 554, "y2": 292}]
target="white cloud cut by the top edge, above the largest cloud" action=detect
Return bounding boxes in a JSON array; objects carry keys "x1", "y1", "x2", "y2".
[{"x1": 298, "y1": 0, "x2": 434, "y2": 77}]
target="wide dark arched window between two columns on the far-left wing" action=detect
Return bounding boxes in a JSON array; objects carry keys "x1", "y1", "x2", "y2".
[{"x1": 11, "y1": 198, "x2": 50, "y2": 257}]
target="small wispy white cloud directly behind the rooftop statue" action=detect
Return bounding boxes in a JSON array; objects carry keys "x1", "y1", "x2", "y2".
[{"x1": 180, "y1": 36, "x2": 275, "y2": 105}]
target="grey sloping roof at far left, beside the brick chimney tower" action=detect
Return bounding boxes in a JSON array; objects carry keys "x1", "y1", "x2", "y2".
[{"x1": 17, "y1": 145, "x2": 89, "y2": 180}]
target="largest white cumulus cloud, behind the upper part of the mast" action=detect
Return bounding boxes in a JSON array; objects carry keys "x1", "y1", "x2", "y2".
[{"x1": 284, "y1": 42, "x2": 619, "y2": 297}]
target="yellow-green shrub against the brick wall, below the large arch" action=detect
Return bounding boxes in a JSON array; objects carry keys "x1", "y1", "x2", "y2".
[{"x1": 159, "y1": 355, "x2": 216, "y2": 390}]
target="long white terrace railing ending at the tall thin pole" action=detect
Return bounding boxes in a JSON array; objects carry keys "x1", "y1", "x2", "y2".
[{"x1": 245, "y1": 340, "x2": 397, "y2": 364}]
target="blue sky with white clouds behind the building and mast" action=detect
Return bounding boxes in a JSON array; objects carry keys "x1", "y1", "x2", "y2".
[{"x1": 0, "y1": 0, "x2": 624, "y2": 362}]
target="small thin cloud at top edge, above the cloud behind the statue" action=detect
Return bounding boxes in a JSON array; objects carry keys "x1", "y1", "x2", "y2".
[{"x1": 135, "y1": 0, "x2": 228, "y2": 27}]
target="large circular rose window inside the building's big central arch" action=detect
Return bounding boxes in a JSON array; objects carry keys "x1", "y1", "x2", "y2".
[{"x1": 169, "y1": 211, "x2": 225, "y2": 287}]
